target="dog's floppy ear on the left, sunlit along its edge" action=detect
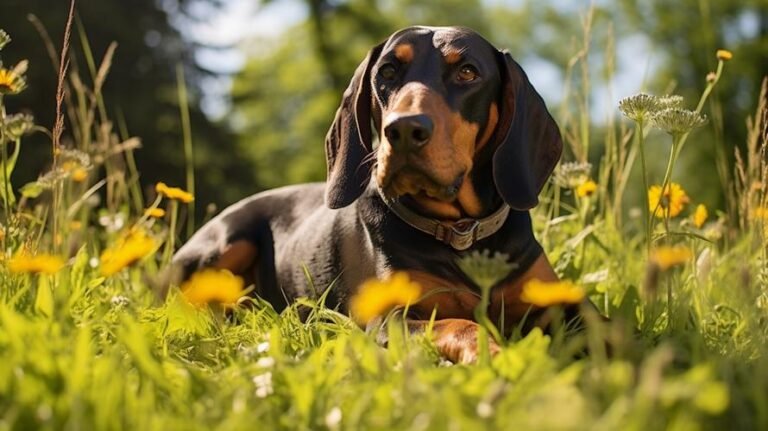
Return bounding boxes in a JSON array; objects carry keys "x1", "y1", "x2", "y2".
[{"x1": 325, "y1": 43, "x2": 384, "y2": 209}]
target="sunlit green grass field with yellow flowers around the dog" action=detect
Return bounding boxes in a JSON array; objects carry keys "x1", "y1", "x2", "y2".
[{"x1": 0, "y1": 13, "x2": 768, "y2": 430}]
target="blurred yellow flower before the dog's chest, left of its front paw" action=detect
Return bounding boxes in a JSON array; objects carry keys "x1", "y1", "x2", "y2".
[{"x1": 349, "y1": 272, "x2": 421, "y2": 324}]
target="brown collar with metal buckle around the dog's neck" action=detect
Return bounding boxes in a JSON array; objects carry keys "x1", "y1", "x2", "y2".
[{"x1": 385, "y1": 200, "x2": 510, "y2": 251}]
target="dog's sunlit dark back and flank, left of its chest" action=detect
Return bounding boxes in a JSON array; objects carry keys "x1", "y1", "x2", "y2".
[{"x1": 173, "y1": 183, "x2": 375, "y2": 310}]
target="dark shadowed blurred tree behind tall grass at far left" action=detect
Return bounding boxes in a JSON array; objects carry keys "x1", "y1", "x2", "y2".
[{"x1": 0, "y1": 0, "x2": 256, "y2": 219}]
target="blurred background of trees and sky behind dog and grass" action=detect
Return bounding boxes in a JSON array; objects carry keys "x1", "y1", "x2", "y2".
[{"x1": 0, "y1": 0, "x2": 768, "y2": 223}]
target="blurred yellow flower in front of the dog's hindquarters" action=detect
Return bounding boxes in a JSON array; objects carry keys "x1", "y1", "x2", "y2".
[{"x1": 181, "y1": 269, "x2": 246, "y2": 306}]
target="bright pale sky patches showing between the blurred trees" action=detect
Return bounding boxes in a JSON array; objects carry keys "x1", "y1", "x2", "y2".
[{"x1": 185, "y1": 0, "x2": 663, "y2": 122}]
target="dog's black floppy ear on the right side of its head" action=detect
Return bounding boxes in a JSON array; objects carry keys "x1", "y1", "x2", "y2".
[{"x1": 493, "y1": 51, "x2": 563, "y2": 211}]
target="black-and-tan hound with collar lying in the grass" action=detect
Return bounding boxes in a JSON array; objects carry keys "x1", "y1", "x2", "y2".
[{"x1": 173, "y1": 27, "x2": 563, "y2": 363}]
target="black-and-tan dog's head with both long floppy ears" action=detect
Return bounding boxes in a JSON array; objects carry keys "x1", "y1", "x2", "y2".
[{"x1": 325, "y1": 27, "x2": 562, "y2": 219}]
